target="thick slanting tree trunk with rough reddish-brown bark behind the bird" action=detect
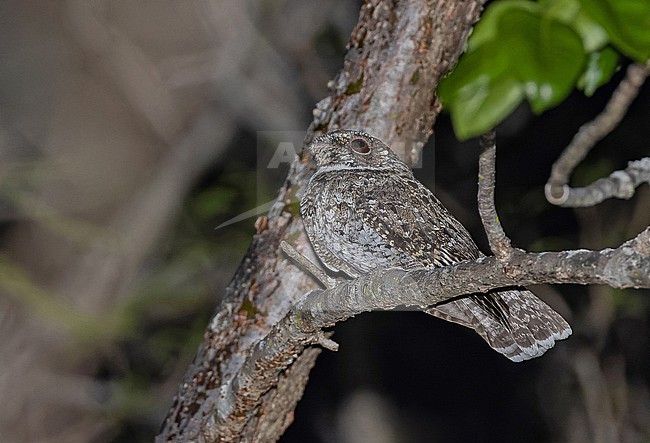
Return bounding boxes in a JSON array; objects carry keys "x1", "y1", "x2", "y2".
[{"x1": 157, "y1": 0, "x2": 483, "y2": 442}]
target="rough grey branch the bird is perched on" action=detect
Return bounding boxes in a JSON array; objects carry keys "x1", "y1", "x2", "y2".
[{"x1": 219, "y1": 228, "x2": 650, "y2": 432}]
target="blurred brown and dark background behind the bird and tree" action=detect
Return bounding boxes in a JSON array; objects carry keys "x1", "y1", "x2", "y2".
[{"x1": 0, "y1": 0, "x2": 650, "y2": 443}]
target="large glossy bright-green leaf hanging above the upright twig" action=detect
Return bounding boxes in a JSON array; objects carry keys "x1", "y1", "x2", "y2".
[{"x1": 438, "y1": 0, "x2": 585, "y2": 139}]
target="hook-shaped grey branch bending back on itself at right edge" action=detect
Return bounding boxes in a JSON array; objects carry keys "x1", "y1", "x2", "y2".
[{"x1": 544, "y1": 62, "x2": 650, "y2": 207}]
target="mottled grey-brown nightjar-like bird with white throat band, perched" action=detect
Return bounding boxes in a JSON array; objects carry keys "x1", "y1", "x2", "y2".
[{"x1": 300, "y1": 130, "x2": 571, "y2": 361}]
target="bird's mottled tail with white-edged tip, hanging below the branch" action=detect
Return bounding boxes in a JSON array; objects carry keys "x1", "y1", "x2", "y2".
[{"x1": 427, "y1": 289, "x2": 572, "y2": 362}]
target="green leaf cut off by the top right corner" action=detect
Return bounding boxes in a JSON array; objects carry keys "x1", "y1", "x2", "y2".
[{"x1": 580, "y1": 0, "x2": 650, "y2": 63}]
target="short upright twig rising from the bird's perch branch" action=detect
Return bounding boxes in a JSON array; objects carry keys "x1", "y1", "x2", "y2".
[{"x1": 478, "y1": 129, "x2": 512, "y2": 260}]
